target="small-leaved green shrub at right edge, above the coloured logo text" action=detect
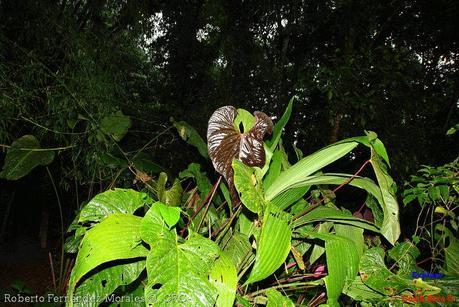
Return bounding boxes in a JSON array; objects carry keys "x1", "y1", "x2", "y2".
[{"x1": 403, "y1": 159, "x2": 459, "y2": 276}]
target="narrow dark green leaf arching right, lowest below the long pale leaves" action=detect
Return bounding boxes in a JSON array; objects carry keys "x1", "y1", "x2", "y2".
[{"x1": 293, "y1": 206, "x2": 379, "y2": 233}]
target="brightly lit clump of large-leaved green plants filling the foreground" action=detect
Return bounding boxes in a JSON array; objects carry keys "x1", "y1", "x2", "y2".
[{"x1": 59, "y1": 103, "x2": 457, "y2": 306}]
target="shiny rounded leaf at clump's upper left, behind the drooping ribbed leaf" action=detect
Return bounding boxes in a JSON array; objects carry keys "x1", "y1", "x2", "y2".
[{"x1": 78, "y1": 189, "x2": 153, "y2": 223}]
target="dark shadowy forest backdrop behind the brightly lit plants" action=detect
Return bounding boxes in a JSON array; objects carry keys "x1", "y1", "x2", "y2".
[{"x1": 0, "y1": 0, "x2": 459, "y2": 296}]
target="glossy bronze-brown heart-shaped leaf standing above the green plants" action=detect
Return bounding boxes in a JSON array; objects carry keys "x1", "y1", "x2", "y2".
[{"x1": 207, "y1": 106, "x2": 273, "y2": 203}]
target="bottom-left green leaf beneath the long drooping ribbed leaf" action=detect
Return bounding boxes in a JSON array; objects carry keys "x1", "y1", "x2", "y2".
[{"x1": 74, "y1": 260, "x2": 145, "y2": 307}]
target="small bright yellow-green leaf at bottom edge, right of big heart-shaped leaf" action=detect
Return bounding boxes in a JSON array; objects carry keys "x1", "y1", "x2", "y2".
[{"x1": 209, "y1": 252, "x2": 237, "y2": 307}]
